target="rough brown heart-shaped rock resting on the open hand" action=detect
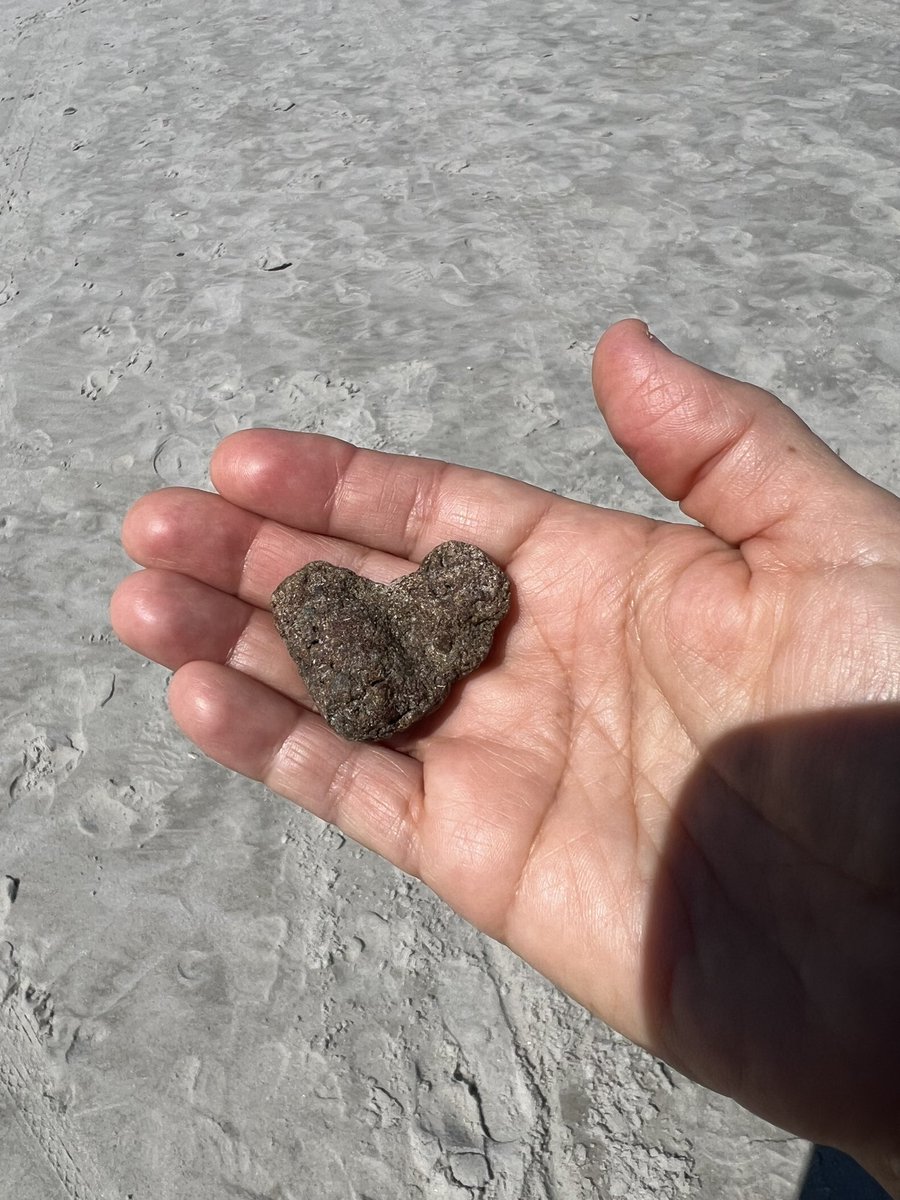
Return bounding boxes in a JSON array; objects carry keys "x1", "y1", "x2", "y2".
[{"x1": 272, "y1": 541, "x2": 510, "y2": 742}]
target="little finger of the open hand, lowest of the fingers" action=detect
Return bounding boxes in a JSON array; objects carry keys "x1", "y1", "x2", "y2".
[{"x1": 169, "y1": 662, "x2": 422, "y2": 874}]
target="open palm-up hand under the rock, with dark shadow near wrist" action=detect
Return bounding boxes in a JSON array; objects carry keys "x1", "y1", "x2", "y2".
[{"x1": 112, "y1": 320, "x2": 900, "y2": 1196}]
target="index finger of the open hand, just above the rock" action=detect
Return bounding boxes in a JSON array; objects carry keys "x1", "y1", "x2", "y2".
[{"x1": 210, "y1": 430, "x2": 554, "y2": 566}]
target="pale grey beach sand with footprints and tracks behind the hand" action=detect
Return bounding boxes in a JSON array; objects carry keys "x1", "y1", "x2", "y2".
[{"x1": 0, "y1": 0, "x2": 900, "y2": 1200}]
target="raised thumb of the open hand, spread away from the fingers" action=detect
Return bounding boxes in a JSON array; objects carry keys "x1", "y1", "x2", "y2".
[{"x1": 593, "y1": 320, "x2": 898, "y2": 562}]
